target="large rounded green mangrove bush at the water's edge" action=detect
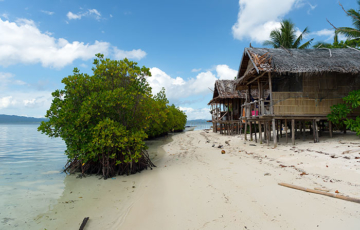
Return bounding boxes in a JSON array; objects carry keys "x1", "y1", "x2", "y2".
[{"x1": 38, "y1": 54, "x2": 186, "y2": 177}]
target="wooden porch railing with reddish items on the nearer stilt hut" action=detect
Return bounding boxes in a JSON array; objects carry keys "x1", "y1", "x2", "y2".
[{"x1": 240, "y1": 99, "x2": 273, "y2": 119}]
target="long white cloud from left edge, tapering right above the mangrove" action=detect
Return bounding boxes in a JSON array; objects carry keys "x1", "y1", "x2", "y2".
[{"x1": 0, "y1": 19, "x2": 146, "y2": 68}]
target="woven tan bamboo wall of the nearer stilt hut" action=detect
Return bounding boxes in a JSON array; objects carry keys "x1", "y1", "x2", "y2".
[{"x1": 273, "y1": 74, "x2": 360, "y2": 116}]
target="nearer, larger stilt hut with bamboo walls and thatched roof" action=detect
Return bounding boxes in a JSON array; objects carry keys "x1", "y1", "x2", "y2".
[{"x1": 235, "y1": 48, "x2": 360, "y2": 146}]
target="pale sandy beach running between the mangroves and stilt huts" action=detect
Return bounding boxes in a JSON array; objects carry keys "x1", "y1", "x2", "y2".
[{"x1": 28, "y1": 131, "x2": 360, "y2": 230}]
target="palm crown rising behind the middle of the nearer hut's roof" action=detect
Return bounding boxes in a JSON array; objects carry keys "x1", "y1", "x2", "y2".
[{"x1": 264, "y1": 20, "x2": 314, "y2": 49}]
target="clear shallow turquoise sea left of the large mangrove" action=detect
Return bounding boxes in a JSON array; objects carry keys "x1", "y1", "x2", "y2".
[{"x1": 0, "y1": 124, "x2": 66, "y2": 229}]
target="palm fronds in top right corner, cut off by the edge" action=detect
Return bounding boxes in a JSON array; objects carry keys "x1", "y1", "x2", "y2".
[{"x1": 336, "y1": 0, "x2": 360, "y2": 40}]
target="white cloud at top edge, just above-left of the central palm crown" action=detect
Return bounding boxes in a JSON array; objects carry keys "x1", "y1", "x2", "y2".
[{"x1": 232, "y1": 0, "x2": 301, "y2": 43}]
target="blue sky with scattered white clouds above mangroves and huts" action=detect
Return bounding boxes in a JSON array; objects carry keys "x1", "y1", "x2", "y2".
[{"x1": 0, "y1": 0, "x2": 358, "y2": 120}]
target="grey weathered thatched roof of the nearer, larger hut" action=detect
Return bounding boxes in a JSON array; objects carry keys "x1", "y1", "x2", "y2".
[{"x1": 237, "y1": 48, "x2": 360, "y2": 79}]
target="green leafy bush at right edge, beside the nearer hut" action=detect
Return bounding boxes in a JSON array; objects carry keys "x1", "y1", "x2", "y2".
[{"x1": 327, "y1": 90, "x2": 360, "y2": 136}]
